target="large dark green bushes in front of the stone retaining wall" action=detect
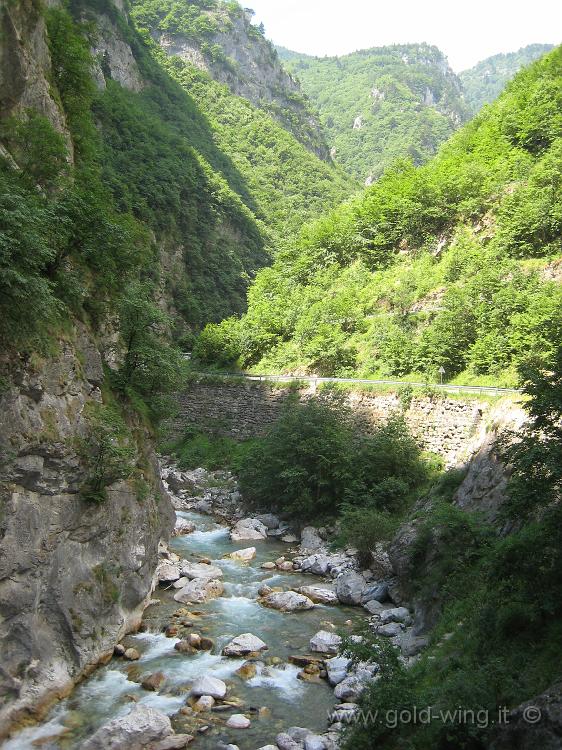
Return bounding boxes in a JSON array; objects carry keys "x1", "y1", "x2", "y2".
[{"x1": 235, "y1": 397, "x2": 426, "y2": 520}]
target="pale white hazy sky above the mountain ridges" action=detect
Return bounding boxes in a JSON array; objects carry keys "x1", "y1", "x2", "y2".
[{"x1": 244, "y1": 0, "x2": 562, "y2": 72}]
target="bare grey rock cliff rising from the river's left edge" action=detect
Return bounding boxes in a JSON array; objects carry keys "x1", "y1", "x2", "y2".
[{"x1": 0, "y1": 327, "x2": 173, "y2": 736}]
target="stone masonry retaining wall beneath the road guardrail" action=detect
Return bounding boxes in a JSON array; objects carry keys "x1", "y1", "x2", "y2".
[{"x1": 173, "y1": 380, "x2": 490, "y2": 466}]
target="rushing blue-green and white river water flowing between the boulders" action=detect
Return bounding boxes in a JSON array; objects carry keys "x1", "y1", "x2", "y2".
[{"x1": 7, "y1": 512, "x2": 362, "y2": 750}]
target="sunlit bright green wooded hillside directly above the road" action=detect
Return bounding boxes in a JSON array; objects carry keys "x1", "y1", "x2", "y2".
[{"x1": 198, "y1": 49, "x2": 562, "y2": 384}]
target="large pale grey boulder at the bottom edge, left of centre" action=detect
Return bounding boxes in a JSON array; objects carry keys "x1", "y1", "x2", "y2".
[{"x1": 82, "y1": 706, "x2": 173, "y2": 750}]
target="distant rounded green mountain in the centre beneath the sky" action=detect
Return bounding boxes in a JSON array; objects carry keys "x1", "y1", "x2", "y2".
[{"x1": 279, "y1": 44, "x2": 468, "y2": 181}]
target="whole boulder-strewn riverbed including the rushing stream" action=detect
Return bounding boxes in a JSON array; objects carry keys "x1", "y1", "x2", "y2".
[{"x1": 5, "y1": 466, "x2": 424, "y2": 750}]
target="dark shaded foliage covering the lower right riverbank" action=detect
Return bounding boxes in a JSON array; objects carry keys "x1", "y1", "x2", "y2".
[{"x1": 345, "y1": 347, "x2": 562, "y2": 750}]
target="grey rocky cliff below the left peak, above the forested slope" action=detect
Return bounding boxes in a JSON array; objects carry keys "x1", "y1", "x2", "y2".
[{"x1": 151, "y1": 6, "x2": 331, "y2": 161}]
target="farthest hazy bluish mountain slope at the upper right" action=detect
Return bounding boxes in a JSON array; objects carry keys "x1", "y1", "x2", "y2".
[{"x1": 459, "y1": 44, "x2": 553, "y2": 114}]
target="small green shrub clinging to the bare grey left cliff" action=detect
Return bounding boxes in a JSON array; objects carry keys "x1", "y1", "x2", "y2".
[{"x1": 77, "y1": 402, "x2": 136, "y2": 503}]
